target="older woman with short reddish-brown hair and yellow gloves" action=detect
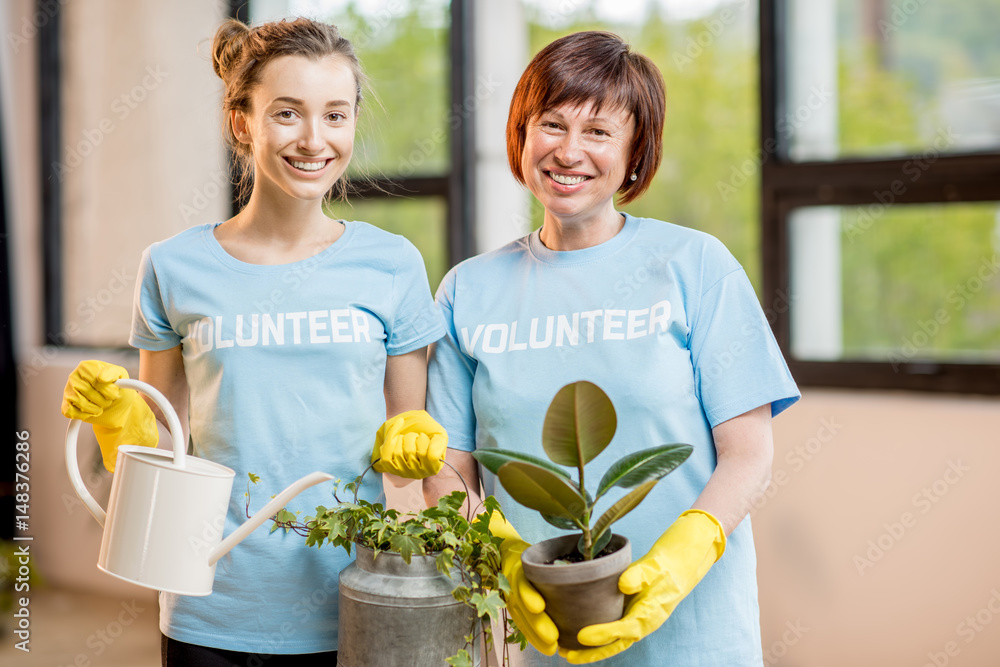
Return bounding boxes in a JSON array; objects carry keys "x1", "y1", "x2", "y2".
[{"x1": 428, "y1": 32, "x2": 798, "y2": 667}]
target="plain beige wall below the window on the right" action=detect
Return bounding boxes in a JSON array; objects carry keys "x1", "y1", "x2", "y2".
[{"x1": 753, "y1": 390, "x2": 1000, "y2": 667}]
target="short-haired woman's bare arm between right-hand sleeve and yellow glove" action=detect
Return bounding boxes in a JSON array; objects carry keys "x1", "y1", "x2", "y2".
[{"x1": 692, "y1": 404, "x2": 774, "y2": 535}]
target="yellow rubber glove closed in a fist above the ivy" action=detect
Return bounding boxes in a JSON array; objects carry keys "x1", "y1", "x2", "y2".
[{"x1": 371, "y1": 410, "x2": 448, "y2": 479}]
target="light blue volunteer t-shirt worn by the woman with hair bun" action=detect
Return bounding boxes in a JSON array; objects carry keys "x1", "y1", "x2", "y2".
[{"x1": 130, "y1": 221, "x2": 444, "y2": 653}]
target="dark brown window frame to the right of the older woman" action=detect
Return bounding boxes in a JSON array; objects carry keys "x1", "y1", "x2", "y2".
[{"x1": 759, "y1": 0, "x2": 1000, "y2": 395}]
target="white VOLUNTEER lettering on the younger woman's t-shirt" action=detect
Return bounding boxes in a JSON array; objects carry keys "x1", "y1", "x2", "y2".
[{"x1": 184, "y1": 308, "x2": 372, "y2": 354}]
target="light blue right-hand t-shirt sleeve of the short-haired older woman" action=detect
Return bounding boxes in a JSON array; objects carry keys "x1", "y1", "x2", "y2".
[{"x1": 690, "y1": 251, "x2": 799, "y2": 428}]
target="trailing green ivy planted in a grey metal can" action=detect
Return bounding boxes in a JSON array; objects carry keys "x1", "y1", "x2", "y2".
[{"x1": 247, "y1": 474, "x2": 524, "y2": 667}]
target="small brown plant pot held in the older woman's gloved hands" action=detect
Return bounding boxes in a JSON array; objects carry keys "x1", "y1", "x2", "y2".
[{"x1": 521, "y1": 535, "x2": 632, "y2": 649}]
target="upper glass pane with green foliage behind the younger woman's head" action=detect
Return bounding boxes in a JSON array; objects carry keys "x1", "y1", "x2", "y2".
[{"x1": 250, "y1": 0, "x2": 452, "y2": 177}]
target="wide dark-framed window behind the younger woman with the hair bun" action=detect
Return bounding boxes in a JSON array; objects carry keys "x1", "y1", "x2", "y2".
[{"x1": 38, "y1": 0, "x2": 475, "y2": 347}]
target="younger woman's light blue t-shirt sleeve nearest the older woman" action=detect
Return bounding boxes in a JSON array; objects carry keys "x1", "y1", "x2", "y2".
[{"x1": 385, "y1": 239, "x2": 444, "y2": 356}]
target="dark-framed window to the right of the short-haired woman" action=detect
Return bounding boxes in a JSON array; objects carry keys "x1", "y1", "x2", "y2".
[{"x1": 760, "y1": 0, "x2": 1000, "y2": 394}]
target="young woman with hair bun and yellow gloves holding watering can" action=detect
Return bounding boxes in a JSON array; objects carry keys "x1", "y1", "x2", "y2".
[{"x1": 63, "y1": 19, "x2": 443, "y2": 667}]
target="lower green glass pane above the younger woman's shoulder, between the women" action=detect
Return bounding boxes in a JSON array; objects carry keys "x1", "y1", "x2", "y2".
[{"x1": 328, "y1": 197, "x2": 448, "y2": 293}]
